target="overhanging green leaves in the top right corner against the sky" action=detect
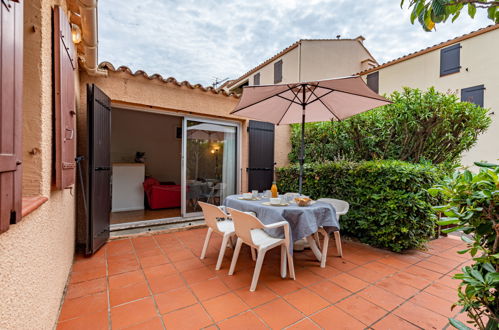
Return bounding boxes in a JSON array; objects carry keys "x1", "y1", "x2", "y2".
[{"x1": 400, "y1": 0, "x2": 499, "y2": 31}]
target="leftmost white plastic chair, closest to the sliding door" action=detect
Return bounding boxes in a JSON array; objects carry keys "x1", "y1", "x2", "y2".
[{"x1": 198, "y1": 202, "x2": 236, "y2": 270}]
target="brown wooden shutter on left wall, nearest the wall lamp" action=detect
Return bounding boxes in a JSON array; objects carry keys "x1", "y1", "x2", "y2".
[{"x1": 54, "y1": 6, "x2": 76, "y2": 189}]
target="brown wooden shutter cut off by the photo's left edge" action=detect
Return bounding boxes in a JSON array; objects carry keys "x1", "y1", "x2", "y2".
[{"x1": 0, "y1": 0, "x2": 23, "y2": 233}]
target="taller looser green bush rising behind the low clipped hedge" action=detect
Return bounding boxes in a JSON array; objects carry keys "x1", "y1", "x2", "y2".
[{"x1": 289, "y1": 88, "x2": 491, "y2": 164}]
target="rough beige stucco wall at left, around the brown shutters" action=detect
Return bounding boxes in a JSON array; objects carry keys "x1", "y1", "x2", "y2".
[{"x1": 0, "y1": 0, "x2": 77, "y2": 330}]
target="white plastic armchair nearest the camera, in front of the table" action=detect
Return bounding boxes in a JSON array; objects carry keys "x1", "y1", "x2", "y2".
[{"x1": 228, "y1": 208, "x2": 296, "y2": 291}]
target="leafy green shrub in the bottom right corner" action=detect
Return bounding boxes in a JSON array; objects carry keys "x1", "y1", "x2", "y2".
[{"x1": 429, "y1": 163, "x2": 499, "y2": 329}]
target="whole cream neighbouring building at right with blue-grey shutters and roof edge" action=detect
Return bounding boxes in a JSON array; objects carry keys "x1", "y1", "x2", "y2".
[{"x1": 360, "y1": 24, "x2": 499, "y2": 165}]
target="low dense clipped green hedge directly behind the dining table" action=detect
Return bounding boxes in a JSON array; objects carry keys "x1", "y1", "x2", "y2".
[{"x1": 276, "y1": 161, "x2": 443, "y2": 252}]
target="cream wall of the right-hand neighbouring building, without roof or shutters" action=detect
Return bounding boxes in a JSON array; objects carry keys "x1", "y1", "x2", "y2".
[{"x1": 364, "y1": 29, "x2": 499, "y2": 166}]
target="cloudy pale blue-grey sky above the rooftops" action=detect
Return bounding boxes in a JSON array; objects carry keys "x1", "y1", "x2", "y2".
[{"x1": 98, "y1": 0, "x2": 491, "y2": 86}]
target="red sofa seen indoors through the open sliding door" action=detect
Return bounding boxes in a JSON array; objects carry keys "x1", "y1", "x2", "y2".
[{"x1": 142, "y1": 178, "x2": 181, "y2": 210}]
